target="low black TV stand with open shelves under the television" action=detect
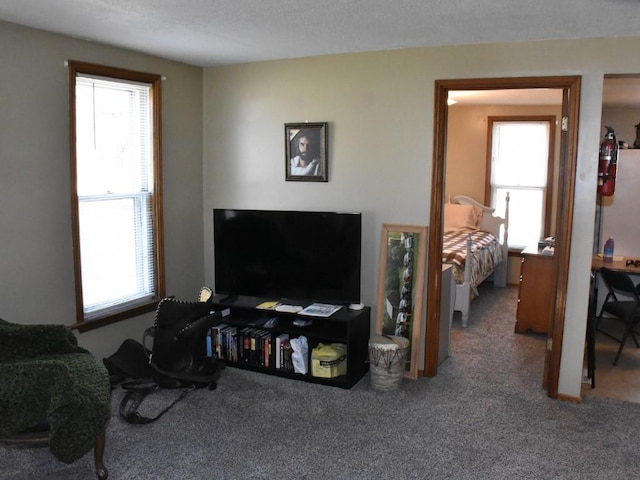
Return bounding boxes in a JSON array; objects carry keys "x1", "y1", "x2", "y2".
[{"x1": 211, "y1": 295, "x2": 371, "y2": 388}]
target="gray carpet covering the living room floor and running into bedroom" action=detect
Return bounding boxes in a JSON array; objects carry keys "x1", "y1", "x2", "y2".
[{"x1": 0, "y1": 287, "x2": 640, "y2": 480}]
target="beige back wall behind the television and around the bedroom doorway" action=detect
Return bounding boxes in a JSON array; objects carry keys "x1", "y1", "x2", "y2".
[{"x1": 204, "y1": 38, "x2": 640, "y2": 396}]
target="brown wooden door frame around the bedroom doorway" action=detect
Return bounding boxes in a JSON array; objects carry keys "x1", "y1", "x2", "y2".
[{"x1": 424, "y1": 76, "x2": 581, "y2": 398}]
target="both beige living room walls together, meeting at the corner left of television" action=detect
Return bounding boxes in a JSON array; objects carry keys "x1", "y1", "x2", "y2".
[{"x1": 6, "y1": 17, "x2": 640, "y2": 396}]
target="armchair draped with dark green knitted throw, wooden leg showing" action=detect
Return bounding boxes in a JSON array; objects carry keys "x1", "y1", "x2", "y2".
[{"x1": 0, "y1": 319, "x2": 111, "y2": 479}]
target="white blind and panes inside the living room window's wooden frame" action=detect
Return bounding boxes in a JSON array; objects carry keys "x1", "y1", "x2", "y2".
[{"x1": 76, "y1": 74, "x2": 155, "y2": 319}]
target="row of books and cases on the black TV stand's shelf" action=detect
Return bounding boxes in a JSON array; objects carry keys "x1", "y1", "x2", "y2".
[{"x1": 207, "y1": 324, "x2": 293, "y2": 371}]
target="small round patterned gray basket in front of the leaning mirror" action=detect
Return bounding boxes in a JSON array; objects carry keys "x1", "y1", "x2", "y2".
[{"x1": 369, "y1": 335, "x2": 409, "y2": 392}]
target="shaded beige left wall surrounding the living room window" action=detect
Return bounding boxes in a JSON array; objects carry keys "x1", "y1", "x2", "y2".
[{"x1": 0, "y1": 22, "x2": 204, "y2": 358}]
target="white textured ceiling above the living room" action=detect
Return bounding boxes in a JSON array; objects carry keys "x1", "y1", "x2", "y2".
[{"x1": 0, "y1": 0, "x2": 640, "y2": 67}]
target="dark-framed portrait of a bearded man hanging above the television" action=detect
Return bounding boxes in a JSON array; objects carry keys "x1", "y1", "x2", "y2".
[{"x1": 284, "y1": 122, "x2": 329, "y2": 182}]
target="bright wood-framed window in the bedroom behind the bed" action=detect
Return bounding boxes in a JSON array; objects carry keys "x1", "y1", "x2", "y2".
[{"x1": 488, "y1": 117, "x2": 555, "y2": 248}]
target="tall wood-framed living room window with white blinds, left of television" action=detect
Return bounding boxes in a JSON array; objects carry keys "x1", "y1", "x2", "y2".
[{"x1": 69, "y1": 62, "x2": 164, "y2": 331}]
